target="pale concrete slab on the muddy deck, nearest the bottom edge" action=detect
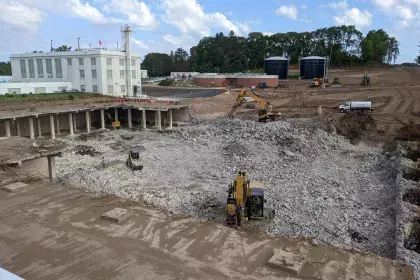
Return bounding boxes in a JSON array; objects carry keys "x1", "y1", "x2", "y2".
[{"x1": 267, "y1": 242, "x2": 310, "y2": 276}]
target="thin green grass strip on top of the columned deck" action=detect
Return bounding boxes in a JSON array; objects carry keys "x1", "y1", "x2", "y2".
[{"x1": 0, "y1": 92, "x2": 104, "y2": 102}]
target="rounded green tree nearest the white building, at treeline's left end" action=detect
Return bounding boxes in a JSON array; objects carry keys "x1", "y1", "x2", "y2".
[{"x1": 142, "y1": 53, "x2": 173, "y2": 77}]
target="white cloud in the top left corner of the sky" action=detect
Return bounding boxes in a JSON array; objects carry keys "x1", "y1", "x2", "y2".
[{"x1": 0, "y1": 0, "x2": 45, "y2": 32}]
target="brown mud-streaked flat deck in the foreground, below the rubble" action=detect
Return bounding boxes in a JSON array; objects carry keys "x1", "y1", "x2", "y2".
[{"x1": 0, "y1": 182, "x2": 413, "y2": 280}]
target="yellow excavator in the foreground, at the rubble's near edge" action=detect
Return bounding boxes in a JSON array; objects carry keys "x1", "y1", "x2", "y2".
[{"x1": 226, "y1": 171, "x2": 275, "y2": 227}]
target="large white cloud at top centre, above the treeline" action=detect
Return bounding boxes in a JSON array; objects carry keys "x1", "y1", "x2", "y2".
[{"x1": 160, "y1": 0, "x2": 246, "y2": 37}]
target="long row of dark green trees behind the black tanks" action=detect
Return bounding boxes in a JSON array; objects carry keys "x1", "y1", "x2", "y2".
[{"x1": 142, "y1": 25, "x2": 399, "y2": 76}]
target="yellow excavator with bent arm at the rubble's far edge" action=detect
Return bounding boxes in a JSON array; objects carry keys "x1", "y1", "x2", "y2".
[{"x1": 229, "y1": 88, "x2": 280, "y2": 122}]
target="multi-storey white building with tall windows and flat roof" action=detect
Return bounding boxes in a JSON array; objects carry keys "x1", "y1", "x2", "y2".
[{"x1": 10, "y1": 49, "x2": 141, "y2": 96}]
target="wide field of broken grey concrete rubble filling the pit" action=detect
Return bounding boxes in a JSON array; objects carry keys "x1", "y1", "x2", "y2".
[{"x1": 57, "y1": 119, "x2": 397, "y2": 257}]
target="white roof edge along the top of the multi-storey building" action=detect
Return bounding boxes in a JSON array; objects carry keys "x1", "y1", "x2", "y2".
[{"x1": 10, "y1": 49, "x2": 140, "y2": 59}]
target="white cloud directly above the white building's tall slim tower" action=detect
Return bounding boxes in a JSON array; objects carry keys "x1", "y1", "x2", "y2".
[{"x1": 103, "y1": 0, "x2": 159, "y2": 29}]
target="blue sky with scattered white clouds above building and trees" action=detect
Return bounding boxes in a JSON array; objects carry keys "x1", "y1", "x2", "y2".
[{"x1": 0, "y1": 0, "x2": 420, "y2": 63}]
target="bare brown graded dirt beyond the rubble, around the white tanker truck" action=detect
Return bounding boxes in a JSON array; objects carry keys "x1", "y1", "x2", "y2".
[{"x1": 191, "y1": 68, "x2": 420, "y2": 140}]
